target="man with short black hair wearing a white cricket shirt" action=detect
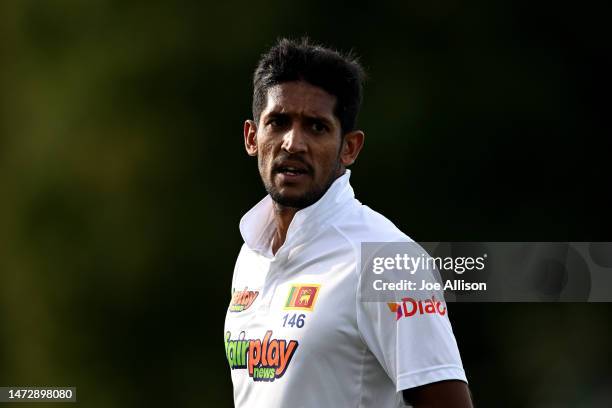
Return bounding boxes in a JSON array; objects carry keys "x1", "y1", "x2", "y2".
[{"x1": 225, "y1": 39, "x2": 471, "y2": 408}]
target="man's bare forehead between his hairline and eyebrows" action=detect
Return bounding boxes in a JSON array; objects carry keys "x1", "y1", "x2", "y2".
[{"x1": 262, "y1": 81, "x2": 339, "y2": 122}]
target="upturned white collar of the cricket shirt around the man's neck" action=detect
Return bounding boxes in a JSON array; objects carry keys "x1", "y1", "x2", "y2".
[{"x1": 240, "y1": 169, "x2": 355, "y2": 254}]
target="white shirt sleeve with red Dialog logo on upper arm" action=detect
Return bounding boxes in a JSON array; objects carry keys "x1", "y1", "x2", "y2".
[{"x1": 357, "y1": 245, "x2": 467, "y2": 392}]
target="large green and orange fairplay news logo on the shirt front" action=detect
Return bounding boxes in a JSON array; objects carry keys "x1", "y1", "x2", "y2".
[{"x1": 225, "y1": 330, "x2": 298, "y2": 381}]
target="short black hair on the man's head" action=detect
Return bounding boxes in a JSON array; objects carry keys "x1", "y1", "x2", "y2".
[{"x1": 253, "y1": 38, "x2": 365, "y2": 135}]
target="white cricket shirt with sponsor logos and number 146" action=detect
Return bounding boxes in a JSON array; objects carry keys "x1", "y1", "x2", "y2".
[{"x1": 224, "y1": 170, "x2": 466, "y2": 408}]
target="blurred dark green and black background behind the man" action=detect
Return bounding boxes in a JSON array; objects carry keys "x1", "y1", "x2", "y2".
[{"x1": 0, "y1": 0, "x2": 612, "y2": 407}]
